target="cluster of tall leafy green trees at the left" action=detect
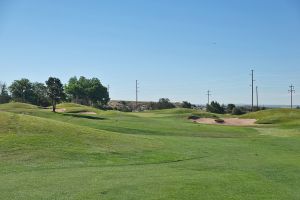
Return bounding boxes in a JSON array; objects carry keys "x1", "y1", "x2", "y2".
[{"x1": 0, "y1": 76, "x2": 109, "y2": 112}]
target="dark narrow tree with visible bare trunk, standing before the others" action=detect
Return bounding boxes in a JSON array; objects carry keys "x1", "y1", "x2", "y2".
[{"x1": 46, "y1": 77, "x2": 65, "y2": 112}]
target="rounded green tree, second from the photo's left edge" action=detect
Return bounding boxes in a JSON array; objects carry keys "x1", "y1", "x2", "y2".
[{"x1": 9, "y1": 78, "x2": 33, "y2": 103}]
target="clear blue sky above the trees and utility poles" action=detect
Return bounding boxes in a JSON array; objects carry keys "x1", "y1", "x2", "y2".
[{"x1": 0, "y1": 0, "x2": 300, "y2": 104}]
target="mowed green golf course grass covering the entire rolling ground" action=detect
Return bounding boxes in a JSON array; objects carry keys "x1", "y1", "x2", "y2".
[{"x1": 0, "y1": 103, "x2": 300, "y2": 200}]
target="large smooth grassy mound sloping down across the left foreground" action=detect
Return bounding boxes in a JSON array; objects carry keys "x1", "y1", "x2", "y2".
[{"x1": 0, "y1": 112, "x2": 169, "y2": 170}]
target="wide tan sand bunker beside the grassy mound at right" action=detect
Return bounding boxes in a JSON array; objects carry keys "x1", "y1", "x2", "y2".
[{"x1": 193, "y1": 118, "x2": 256, "y2": 126}]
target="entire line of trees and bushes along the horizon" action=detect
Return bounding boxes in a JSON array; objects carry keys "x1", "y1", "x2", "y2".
[{"x1": 0, "y1": 76, "x2": 290, "y2": 115}]
